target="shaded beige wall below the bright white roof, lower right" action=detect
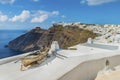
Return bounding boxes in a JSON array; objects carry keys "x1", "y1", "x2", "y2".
[{"x1": 58, "y1": 55, "x2": 120, "y2": 80}]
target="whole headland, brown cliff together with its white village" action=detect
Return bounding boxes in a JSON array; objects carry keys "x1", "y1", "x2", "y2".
[{"x1": 8, "y1": 22, "x2": 120, "y2": 52}]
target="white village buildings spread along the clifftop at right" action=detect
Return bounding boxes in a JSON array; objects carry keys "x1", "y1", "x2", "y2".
[{"x1": 55, "y1": 22, "x2": 120, "y2": 43}]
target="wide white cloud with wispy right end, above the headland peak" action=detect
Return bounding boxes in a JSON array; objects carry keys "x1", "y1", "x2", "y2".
[{"x1": 31, "y1": 10, "x2": 59, "y2": 23}]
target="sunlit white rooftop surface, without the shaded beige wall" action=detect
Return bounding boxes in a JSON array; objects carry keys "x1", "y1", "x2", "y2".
[{"x1": 0, "y1": 44, "x2": 119, "y2": 80}]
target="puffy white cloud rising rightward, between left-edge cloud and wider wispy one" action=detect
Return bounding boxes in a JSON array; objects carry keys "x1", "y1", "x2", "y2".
[{"x1": 9, "y1": 10, "x2": 30, "y2": 22}]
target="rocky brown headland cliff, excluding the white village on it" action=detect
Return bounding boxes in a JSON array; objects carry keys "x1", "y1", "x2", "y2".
[{"x1": 8, "y1": 25, "x2": 97, "y2": 52}]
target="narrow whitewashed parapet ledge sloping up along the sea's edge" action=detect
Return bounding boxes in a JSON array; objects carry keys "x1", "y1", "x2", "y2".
[{"x1": 0, "y1": 50, "x2": 39, "y2": 65}]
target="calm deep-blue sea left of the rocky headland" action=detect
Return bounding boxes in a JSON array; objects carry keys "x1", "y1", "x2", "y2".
[{"x1": 0, "y1": 30, "x2": 27, "y2": 59}]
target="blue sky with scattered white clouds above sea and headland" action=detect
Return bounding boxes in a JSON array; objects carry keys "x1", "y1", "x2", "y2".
[{"x1": 0, "y1": 0, "x2": 120, "y2": 30}]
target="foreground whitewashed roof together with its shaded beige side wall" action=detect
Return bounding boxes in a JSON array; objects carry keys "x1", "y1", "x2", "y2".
[{"x1": 0, "y1": 45, "x2": 120, "y2": 80}]
